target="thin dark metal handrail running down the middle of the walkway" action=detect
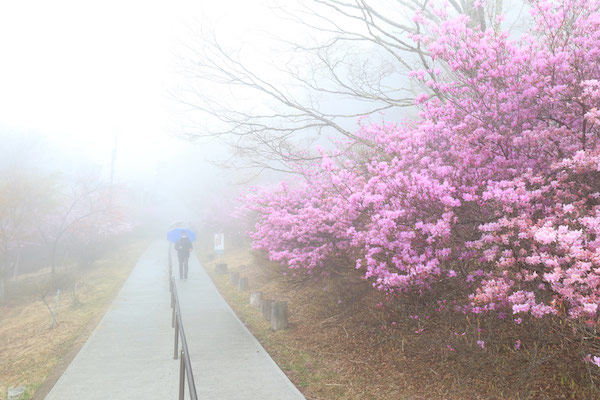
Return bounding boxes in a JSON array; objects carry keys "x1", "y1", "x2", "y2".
[{"x1": 169, "y1": 276, "x2": 198, "y2": 400}]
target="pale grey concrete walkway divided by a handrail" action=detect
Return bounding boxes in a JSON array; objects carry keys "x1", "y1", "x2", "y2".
[{"x1": 46, "y1": 241, "x2": 304, "y2": 400}]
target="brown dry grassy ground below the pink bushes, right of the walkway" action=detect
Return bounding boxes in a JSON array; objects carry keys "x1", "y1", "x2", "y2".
[{"x1": 199, "y1": 248, "x2": 597, "y2": 400}]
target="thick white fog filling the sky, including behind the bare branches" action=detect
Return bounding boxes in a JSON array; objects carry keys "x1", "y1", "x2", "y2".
[{"x1": 0, "y1": 0, "x2": 526, "y2": 272}]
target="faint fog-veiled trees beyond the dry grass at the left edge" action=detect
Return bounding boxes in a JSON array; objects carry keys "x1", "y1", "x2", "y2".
[{"x1": 0, "y1": 132, "x2": 136, "y2": 301}]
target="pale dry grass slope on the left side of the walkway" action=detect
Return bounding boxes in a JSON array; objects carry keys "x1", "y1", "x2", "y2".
[{"x1": 0, "y1": 243, "x2": 146, "y2": 399}]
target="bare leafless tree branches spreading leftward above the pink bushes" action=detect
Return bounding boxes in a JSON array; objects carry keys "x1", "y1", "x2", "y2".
[{"x1": 173, "y1": 0, "x2": 502, "y2": 171}]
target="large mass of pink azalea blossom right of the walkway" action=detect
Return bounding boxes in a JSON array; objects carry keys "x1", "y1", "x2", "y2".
[{"x1": 244, "y1": 0, "x2": 600, "y2": 330}]
